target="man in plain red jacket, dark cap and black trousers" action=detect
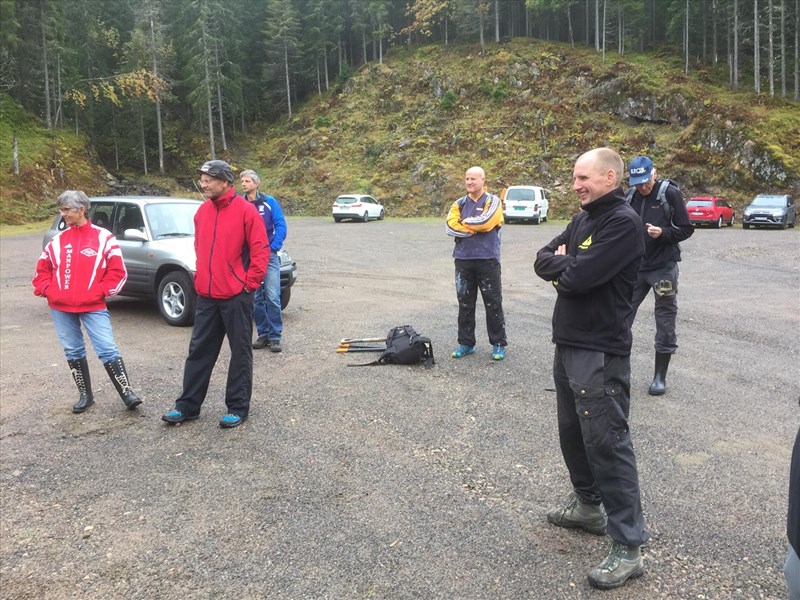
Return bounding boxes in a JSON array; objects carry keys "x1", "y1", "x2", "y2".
[{"x1": 161, "y1": 160, "x2": 269, "y2": 427}]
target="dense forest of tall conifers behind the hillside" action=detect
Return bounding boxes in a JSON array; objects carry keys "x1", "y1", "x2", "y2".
[{"x1": 0, "y1": 0, "x2": 800, "y2": 173}]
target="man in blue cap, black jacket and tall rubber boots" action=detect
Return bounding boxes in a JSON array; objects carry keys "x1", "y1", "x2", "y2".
[{"x1": 628, "y1": 156, "x2": 694, "y2": 396}]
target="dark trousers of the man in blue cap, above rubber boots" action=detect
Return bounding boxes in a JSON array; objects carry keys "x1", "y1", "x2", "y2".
[{"x1": 631, "y1": 262, "x2": 678, "y2": 354}]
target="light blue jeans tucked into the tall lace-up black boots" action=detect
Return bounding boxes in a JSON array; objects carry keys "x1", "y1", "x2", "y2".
[{"x1": 50, "y1": 308, "x2": 119, "y2": 363}]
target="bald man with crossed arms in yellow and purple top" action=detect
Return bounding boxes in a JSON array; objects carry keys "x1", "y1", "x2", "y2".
[{"x1": 446, "y1": 167, "x2": 508, "y2": 360}]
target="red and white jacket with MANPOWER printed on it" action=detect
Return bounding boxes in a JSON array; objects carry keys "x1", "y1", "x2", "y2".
[{"x1": 33, "y1": 221, "x2": 128, "y2": 312}]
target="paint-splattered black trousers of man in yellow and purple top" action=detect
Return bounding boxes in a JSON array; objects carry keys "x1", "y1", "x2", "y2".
[{"x1": 455, "y1": 258, "x2": 508, "y2": 346}]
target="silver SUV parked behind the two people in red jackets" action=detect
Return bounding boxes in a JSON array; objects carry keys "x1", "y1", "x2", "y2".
[{"x1": 42, "y1": 196, "x2": 297, "y2": 325}]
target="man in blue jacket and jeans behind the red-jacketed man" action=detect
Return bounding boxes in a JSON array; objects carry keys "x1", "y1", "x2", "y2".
[{"x1": 239, "y1": 170, "x2": 286, "y2": 352}]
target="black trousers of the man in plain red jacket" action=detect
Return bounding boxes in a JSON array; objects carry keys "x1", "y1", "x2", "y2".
[{"x1": 175, "y1": 292, "x2": 253, "y2": 417}]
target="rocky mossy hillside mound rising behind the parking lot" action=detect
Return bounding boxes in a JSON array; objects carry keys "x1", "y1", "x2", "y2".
[{"x1": 247, "y1": 39, "x2": 800, "y2": 216}]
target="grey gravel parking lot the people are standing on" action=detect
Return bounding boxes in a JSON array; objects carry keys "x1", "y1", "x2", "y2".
[{"x1": 0, "y1": 218, "x2": 800, "y2": 599}]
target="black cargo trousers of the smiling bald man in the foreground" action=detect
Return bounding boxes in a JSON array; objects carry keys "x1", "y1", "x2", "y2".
[{"x1": 553, "y1": 345, "x2": 648, "y2": 546}]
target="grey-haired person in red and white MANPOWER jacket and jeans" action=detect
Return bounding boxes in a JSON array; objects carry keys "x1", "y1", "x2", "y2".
[{"x1": 33, "y1": 190, "x2": 142, "y2": 413}]
